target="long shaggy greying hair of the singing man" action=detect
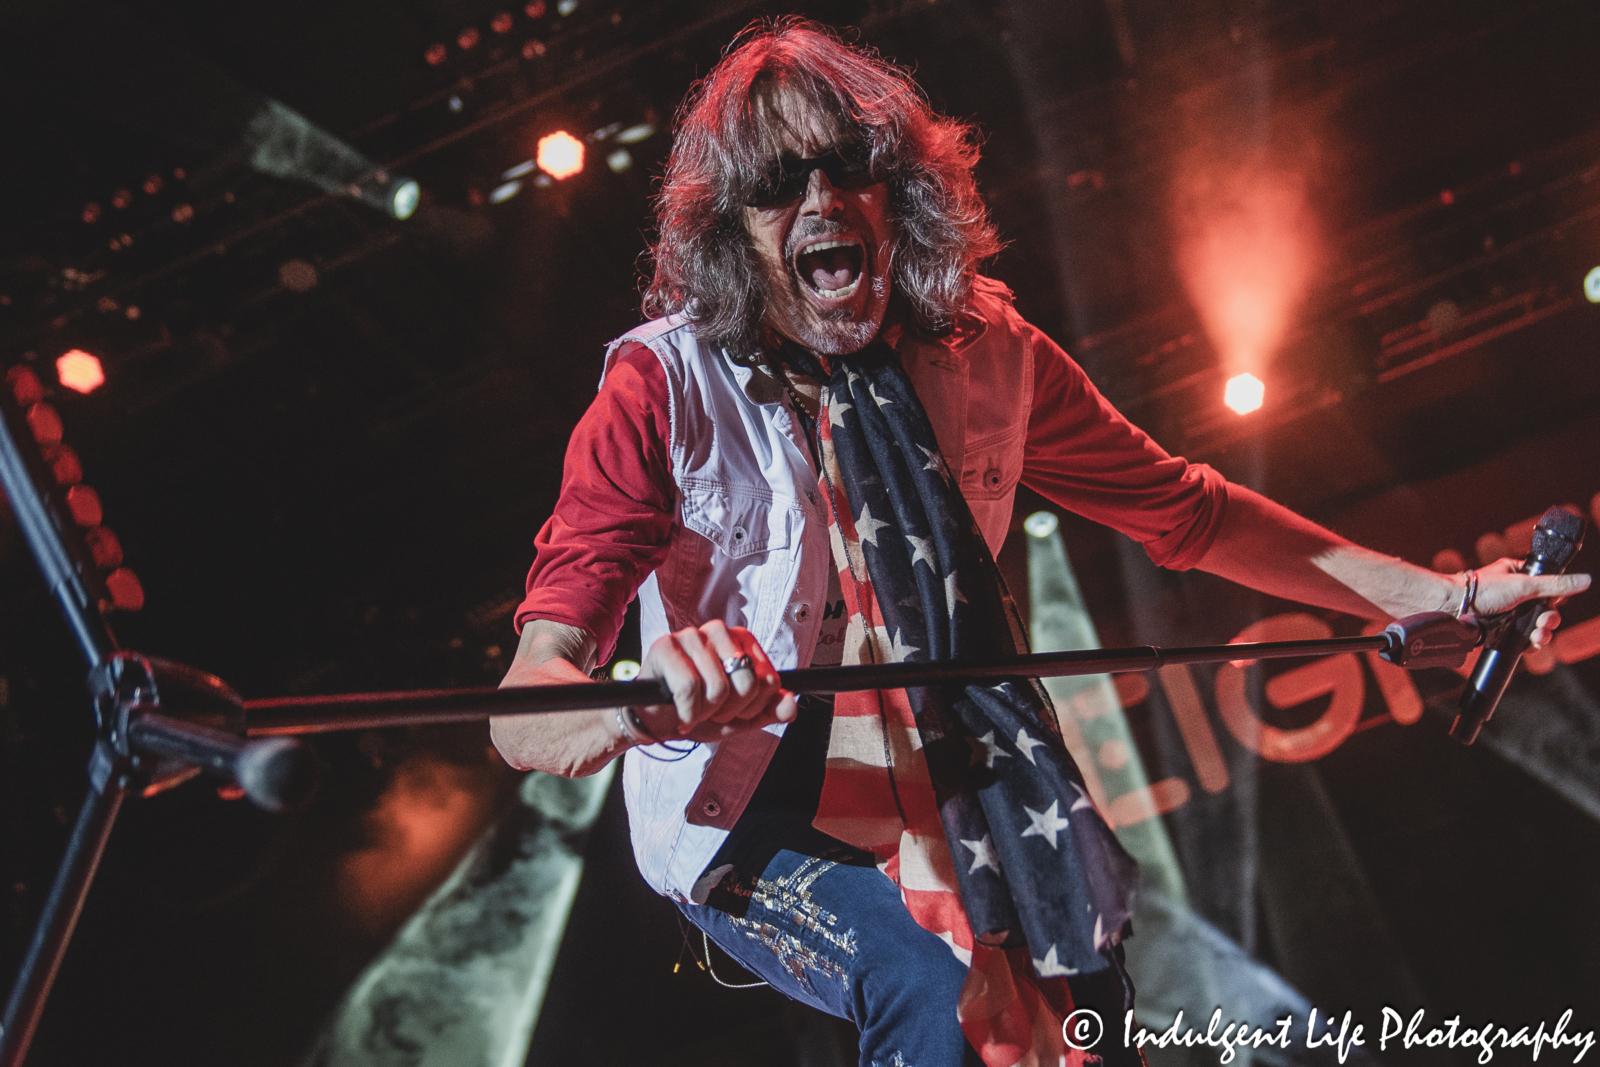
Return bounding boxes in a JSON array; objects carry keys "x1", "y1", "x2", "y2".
[{"x1": 645, "y1": 18, "x2": 1000, "y2": 363}]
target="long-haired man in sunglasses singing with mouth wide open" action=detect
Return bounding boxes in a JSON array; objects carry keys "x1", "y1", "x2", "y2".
[{"x1": 493, "y1": 21, "x2": 1589, "y2": 1067}]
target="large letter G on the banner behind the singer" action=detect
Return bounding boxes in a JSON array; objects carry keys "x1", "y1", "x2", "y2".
[{"x1": 1216, "y1": 613, "x2": 1366, "y2": 763}]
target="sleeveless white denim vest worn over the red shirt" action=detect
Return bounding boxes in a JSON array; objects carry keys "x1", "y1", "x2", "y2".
[{"x1": 606, "y1": 278, "x2": 1034, "y2": 902}]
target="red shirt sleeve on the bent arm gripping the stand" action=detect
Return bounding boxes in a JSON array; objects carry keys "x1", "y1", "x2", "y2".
[{"x1": 517, "y1": 344, "x2": 677, "y2": 662}]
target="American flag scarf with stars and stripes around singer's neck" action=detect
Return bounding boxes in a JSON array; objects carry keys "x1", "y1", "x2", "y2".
[{"x1": 782, "y1": 341, "x2": 1138, "y2": 1067}]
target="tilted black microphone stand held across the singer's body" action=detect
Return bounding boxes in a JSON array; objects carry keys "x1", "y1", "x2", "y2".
[{"x1": 0, "y1": 379, "x2": 1482, "y2": 1067}]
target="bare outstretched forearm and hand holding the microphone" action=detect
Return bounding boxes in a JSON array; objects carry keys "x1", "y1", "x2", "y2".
[{"x1": 1198, "y1": 485, "x2": 1589, "y2": 645}]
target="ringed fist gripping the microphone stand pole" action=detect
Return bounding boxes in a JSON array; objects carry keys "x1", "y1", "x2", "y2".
[{"x1": 634, "y1": 619, "x2": 798, "y2": 741}]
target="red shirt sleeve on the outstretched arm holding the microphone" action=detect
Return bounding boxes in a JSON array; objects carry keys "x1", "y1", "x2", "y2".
[{"x1": 1022, "y1": 326, "x2": 1229, "y2": 569}]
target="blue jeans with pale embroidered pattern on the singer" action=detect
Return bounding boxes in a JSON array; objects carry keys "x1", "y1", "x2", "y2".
[{"x1": 678, "y1": 811, "x2": 982, "y2": 1067}]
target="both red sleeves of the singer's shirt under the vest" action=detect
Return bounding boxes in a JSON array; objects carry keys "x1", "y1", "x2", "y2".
[{"x1": 517, "y1": 330, "x2": 1227, "y2": 662}]
